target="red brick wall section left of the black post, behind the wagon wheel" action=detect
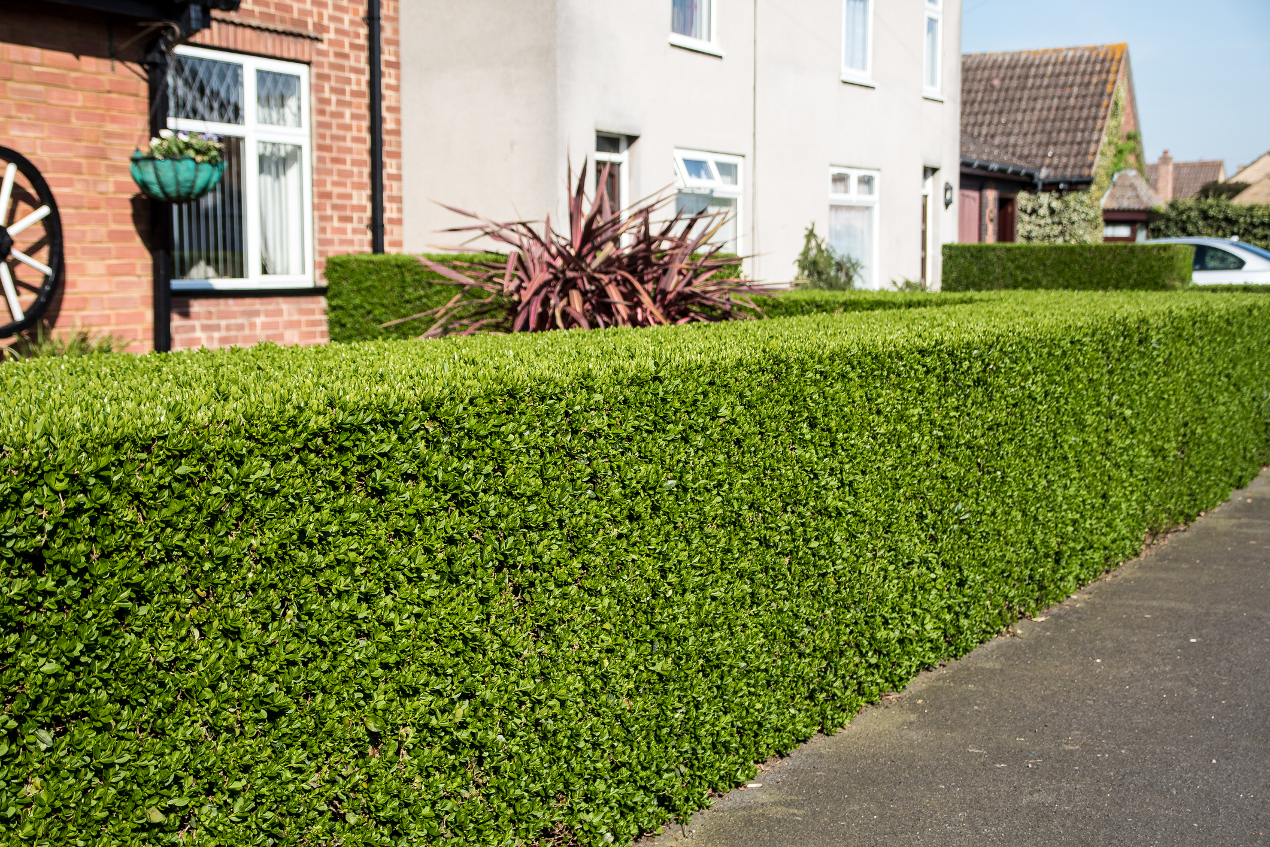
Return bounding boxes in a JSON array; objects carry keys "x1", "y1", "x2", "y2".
[{"x1": 0, "y1": 3, "x2": 152, "y2": 352}]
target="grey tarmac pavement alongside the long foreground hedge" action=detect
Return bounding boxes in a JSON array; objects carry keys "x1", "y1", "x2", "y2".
[{"x1": 641, "y1": 472, "x2": 1270, "y2": 847}]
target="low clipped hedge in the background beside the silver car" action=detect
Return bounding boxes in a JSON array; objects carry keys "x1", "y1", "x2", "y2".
[{"x1": 944, "y1": 244, "x2": 1195, "y2": 291}]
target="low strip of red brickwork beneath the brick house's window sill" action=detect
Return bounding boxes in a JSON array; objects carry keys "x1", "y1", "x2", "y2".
[{"x1": 171, "y1": 296, "x2": 329, "y2": 350}]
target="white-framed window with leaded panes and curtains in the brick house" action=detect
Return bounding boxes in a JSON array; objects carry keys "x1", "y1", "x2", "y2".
[{"x1": 168, "y1": 46, "x2": 314, "y2": 291}]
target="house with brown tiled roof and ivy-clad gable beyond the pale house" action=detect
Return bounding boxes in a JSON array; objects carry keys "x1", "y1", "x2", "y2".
[{"x1": 959, "y1": 44, "x2": 1144, "y2": 243}]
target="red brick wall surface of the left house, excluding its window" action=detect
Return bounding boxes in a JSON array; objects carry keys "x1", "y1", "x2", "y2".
[{"x1": 0, "y1": 0, "x2": 401, "y2": 352}]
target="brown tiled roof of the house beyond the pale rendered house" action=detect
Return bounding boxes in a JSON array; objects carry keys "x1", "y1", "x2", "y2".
[{"x1": 961, "y1": 44, "x2": 1129, "y2": 180}]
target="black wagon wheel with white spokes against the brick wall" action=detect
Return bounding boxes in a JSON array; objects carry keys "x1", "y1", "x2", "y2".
[{"x1": 0, "y1": 147, "x2": 62, "y2": 338}]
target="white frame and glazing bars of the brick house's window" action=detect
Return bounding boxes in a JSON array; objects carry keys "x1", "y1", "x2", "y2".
[{"x1": 168, "y1": 44, "x2": 315, "y2": 291}]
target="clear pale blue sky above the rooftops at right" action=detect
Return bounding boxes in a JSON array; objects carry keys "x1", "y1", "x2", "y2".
[{"x1": 961, "y1": 0, "x2": 1270, "y2": 177}]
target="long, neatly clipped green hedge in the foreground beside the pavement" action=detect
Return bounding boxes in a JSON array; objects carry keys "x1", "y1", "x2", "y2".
[{"x1": 0, "y1": 292, "x2": 1270, "y2": 847}]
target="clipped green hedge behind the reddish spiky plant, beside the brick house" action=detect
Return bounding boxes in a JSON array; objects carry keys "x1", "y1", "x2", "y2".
[{"x1": 325, "y1": 253, "x2": 742, "y2": 342}]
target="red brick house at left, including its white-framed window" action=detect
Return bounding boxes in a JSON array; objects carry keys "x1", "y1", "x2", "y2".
[{"x1": 0, "y1": 0, "x2": 401, "y2": 352}]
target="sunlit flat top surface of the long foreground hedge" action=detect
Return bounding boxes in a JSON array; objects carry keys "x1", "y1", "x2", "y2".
[{"x1": 0, "y1": 292, "x2": 1255, "y2": 450}]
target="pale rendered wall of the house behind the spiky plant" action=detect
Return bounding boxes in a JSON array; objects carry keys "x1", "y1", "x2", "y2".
[{"x1": 403, "y1": 0, "x2": 960, "y2": 287}]
